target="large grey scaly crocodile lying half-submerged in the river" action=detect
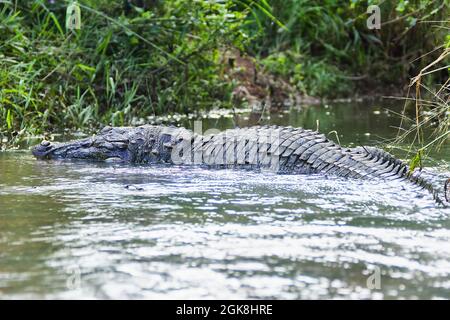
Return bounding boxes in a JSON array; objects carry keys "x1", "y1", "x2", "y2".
[{"x1": 32, "y1": 125, "x2": 449, "y2": 206}]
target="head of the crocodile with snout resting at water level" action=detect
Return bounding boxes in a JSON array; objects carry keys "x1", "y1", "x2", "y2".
[{"x1": 32, "y1": 127, "x2": 130, "y2": 161}]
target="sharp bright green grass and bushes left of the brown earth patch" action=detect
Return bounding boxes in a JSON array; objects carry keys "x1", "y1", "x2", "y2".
[{"x1": 0, "y1": 0, "x2": 247, "y2": 135}]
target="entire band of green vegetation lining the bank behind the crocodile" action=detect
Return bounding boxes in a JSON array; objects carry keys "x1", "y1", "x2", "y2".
[{"x1": 0, "y1": 0, "x2": 450, "y2": 146}]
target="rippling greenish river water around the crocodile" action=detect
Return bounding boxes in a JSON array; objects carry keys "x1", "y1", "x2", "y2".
[{"x1": 0, "y1": 101, "x2": 450, "y2": 299}]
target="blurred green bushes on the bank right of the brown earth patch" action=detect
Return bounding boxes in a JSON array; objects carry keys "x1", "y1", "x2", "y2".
[{"x1": 247, "y1": 0, "x2": 450, "y2": 96}]
